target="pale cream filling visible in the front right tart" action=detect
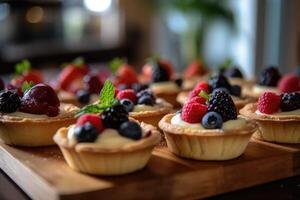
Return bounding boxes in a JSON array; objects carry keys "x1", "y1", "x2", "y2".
[{"x1": 171, "y1": 114, "x2": 247, "y2": 130}]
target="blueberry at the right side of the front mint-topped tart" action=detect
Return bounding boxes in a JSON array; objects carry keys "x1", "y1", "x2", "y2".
[{"x1": 119, "y1": 121, "x2": 142, "y2": 140}]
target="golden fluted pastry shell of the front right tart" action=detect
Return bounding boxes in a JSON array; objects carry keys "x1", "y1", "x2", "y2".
[{"x1": 159, "y1": 114, "x2": 257, "y2": 160}]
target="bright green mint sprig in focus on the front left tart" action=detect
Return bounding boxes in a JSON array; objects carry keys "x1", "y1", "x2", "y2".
[{"x1": 76, "y1": 80, "x2": 118, "y2": 117}]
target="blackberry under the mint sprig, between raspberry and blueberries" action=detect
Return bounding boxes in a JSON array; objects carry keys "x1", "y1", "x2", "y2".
[{"x1": 101, "y1": 104, "x2": 128, "y2": 129}]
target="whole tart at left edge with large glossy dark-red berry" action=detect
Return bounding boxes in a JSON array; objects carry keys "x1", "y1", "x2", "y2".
[{"x1": 0, "y1": 83, "x2": 78, "y2": 146}]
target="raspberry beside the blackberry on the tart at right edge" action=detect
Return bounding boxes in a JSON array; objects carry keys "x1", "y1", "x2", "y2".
[{"x1": 257, "y1": 92, "x2": 281, "y2": 114}]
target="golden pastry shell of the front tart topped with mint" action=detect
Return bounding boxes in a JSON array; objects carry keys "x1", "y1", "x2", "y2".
[{"x1": 54, "y1": 123, "x2": 160, "y2": 175}]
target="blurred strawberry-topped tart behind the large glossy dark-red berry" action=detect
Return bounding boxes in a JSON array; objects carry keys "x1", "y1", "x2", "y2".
[{"x1": 56, "y1": 58, "x2": 103, "y2": 107}]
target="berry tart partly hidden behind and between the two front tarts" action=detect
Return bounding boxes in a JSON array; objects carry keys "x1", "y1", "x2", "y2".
[{"x1": 117, "y1": 89, "x2": 173, "y2": 127}]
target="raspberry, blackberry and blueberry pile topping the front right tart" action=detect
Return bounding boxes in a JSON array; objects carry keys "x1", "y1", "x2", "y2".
[{"x1": 181, "y1": 82, "x2": 237, "y2": 129}]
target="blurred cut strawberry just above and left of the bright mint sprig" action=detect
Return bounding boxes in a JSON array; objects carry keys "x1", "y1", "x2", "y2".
[{"x1": 58, "y1": 64, "x2": 89, "y2": 93}]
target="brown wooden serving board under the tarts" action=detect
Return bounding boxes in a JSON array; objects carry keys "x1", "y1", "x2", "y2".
[{"x1": 0, "y1": 140, "x2": 300, "y2": 199}]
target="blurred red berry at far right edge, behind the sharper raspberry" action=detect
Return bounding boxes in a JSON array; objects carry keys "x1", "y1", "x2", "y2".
[{"x1": 278, "y1": 74, "x2": 300, "y2": 92}]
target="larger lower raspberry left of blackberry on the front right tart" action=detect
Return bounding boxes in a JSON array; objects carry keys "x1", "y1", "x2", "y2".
[{"x1": 181, "y1": 102, "x2": 207, "y2": 123}]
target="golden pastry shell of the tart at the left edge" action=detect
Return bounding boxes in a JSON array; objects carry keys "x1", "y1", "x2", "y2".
[{"x1": 0, "y1": 104, "x2": 79, "y2": 147}]
